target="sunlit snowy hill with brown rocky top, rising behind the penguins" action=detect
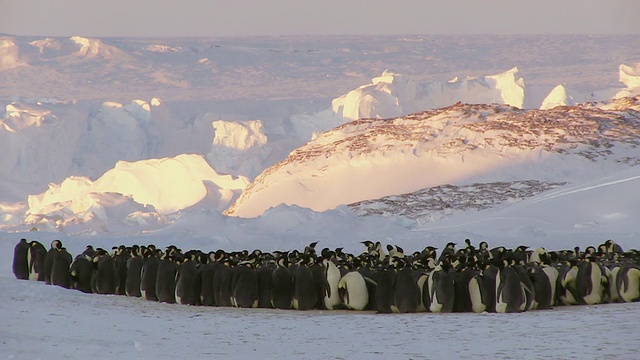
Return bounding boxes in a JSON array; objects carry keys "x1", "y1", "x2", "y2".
[{"x1": 226, "y1": 98, "x2": 640, "y2": 217}]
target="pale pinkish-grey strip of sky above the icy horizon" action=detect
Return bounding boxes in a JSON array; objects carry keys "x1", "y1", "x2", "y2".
[{"x1": 0, "y1": 0, "x2": 640, "y2": 37}]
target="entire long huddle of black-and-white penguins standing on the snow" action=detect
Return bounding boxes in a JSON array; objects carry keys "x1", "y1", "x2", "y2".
[{"x1": 13, "y1": 239, "x2": 640, "y2": 313}]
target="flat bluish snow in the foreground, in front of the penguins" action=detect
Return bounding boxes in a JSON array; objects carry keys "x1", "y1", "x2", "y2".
[{"x1": 0, "y1": 276, "x2": 640, "y2": 360}]
